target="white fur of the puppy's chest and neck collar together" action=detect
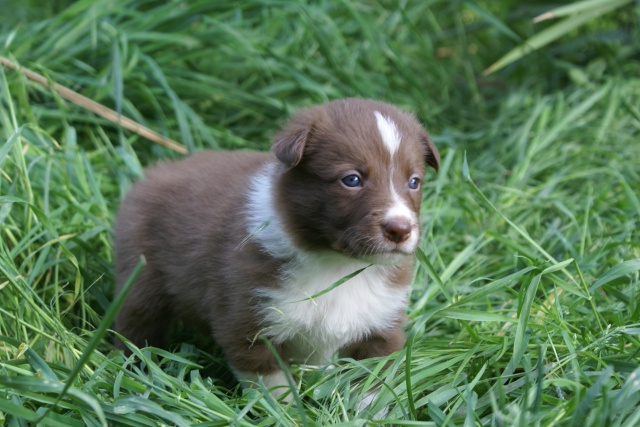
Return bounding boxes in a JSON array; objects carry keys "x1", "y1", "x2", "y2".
[{"x1": 245, "y1": 163, "x2": 408, "y2": 364}]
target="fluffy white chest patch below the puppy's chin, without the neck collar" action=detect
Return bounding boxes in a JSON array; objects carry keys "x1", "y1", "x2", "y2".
[{"x1": 254, "y1": 253, "x2": 407, "y2": 364}]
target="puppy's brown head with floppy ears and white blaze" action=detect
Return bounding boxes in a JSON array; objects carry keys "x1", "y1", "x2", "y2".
[{"x1": 273, "y1": 99, "x2": 440, "y2": 263}]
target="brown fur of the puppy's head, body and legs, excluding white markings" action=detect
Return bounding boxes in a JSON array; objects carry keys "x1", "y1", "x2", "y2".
[{"x1": 115, "y1": 100, "x2": 439, "y2": 382}]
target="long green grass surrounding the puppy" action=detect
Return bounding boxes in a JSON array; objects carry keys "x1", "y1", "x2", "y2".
[{"x1": 0, "y1": 0, "x2": 640, "y2": 427}]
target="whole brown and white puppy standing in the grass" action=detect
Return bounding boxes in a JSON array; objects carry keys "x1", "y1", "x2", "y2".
[{"x1": 115, "y1": 99, "x2": 439, "y2": 400}]
